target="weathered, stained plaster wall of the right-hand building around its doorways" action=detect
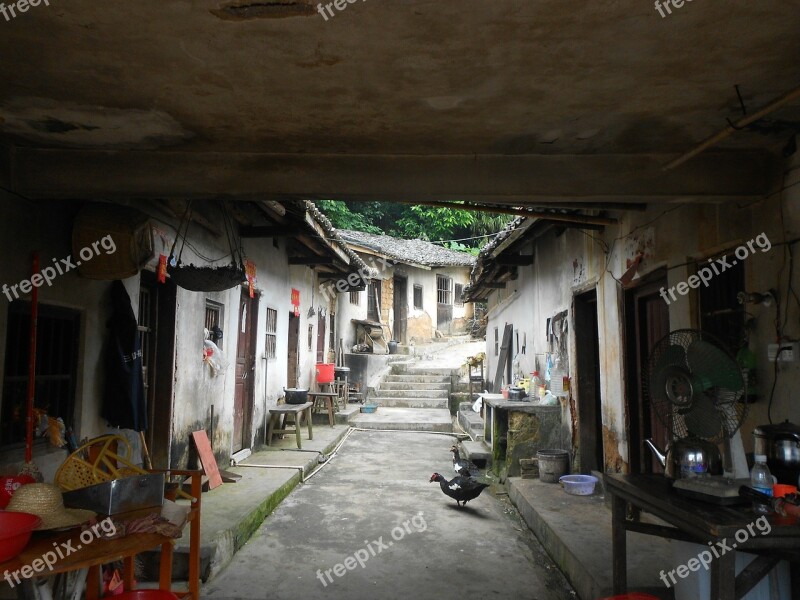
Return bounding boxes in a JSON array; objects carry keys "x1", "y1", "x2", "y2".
[{"x1": 487, "y1": 142, "x2": 800, "y2": 471}]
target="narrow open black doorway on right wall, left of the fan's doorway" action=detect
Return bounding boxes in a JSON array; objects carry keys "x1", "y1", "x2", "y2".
[{"x1": 575, "y1": 290, "x2": 605, "y2": 473}]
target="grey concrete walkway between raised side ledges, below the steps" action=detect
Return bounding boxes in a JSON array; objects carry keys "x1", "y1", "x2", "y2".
[{"x1": 202, "y1": 431, "x2": 575, "y2": 600}]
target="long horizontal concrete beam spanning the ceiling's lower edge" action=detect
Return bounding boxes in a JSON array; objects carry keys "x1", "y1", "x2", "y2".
[{"x1": 10, "y1": 147, "x2": 776, "y2": 205}]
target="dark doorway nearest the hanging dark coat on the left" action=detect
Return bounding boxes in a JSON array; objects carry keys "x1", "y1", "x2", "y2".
[{"x1": 138, "y1": 271, "x2": 177, "y2": 469}]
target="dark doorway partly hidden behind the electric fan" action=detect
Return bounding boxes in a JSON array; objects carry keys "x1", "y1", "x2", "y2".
[{"x1": 625, "y1": 274, "x2": 668, "y2": 473}]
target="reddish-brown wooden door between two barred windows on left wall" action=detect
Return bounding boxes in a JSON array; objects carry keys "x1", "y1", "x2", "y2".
[{"x1": 231, "y1": 287, "x2": 258, "y2": 452}]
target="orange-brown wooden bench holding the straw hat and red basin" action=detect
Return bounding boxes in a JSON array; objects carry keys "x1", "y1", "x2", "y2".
[{"x1": 0, "y1": 470, "x2": 202, "y2": 600}]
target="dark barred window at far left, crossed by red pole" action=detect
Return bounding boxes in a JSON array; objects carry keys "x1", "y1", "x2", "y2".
[{"x1": 0, "y1": 302, "x2": 80, "y2": 444}]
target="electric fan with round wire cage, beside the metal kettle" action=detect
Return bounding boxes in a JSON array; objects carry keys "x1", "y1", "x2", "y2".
[{"x1": 643, "y1": 329, "x2": 748, "y2": 499}]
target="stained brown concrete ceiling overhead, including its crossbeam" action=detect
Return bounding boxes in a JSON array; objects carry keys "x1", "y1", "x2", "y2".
[{"x1": 0, "y1": 0, "x2": 800, "y2": 204}]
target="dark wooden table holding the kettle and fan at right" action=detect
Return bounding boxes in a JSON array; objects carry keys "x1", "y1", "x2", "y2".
[{"x1": 603, "y1": 473, "x2": 800, "y2": 600}]
